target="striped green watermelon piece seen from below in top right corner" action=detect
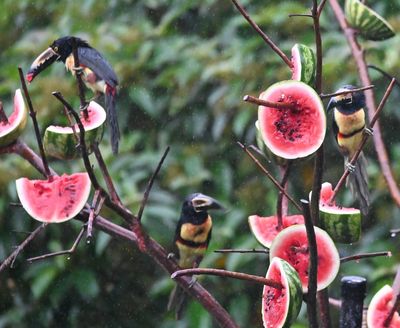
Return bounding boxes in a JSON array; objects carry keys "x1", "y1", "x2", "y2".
[{"x1": 345, "y1": 0, "x2": 395, "y2": 41}]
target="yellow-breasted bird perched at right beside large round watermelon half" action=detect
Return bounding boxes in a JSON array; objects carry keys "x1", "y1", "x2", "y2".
[{"x1": 327, "y1": 85, "x2": 372, "y2": 215}]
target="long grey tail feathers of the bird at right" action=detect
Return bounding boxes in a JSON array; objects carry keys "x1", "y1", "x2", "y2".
[{"x1": 345, "y1": 153, "x2": 370, "y2": 215}]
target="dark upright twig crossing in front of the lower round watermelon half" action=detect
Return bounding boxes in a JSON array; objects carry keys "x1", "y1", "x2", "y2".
[{"x1": 301, "y1": 199, "x2": 318, "y2": 328}]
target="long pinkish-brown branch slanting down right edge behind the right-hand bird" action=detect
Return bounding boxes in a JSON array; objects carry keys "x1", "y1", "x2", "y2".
[{"x1": 329, "y1": 0, "x2": 400, "y2": 206}]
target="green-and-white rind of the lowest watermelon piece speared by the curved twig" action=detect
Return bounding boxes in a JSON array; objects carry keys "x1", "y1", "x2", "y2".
[{"x1": 261, "y1": 257, "x2": 303, "y2": 328}]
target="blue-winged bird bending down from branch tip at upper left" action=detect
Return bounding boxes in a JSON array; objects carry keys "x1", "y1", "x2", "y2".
[{"x1": 26, "y1": 36, "x2": 120, "y2": 154}]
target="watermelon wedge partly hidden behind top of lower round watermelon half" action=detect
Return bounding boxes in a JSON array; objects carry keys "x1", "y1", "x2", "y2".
[{"x1": 249, "y1": 214, "x2": 304, "y2": 248}]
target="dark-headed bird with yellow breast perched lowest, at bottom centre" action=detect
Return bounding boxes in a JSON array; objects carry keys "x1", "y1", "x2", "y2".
[{"x1": 167, "y1": 193, "x2": 224, "y2": 320}]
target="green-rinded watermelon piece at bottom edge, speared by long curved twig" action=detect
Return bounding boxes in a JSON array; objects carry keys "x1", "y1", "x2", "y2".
[{"x1": 261, "y1": 257, "x2": 303, "y2": 328}]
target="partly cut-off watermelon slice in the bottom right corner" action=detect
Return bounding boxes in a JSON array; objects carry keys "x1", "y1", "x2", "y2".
[{"x1": 367, "y1": 285, "x2": 400, "y2": 328}]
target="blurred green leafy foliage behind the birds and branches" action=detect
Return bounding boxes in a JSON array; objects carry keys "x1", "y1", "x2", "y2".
[{"x1": 0, "y1": 0, "x2": 400, "y2": 328}]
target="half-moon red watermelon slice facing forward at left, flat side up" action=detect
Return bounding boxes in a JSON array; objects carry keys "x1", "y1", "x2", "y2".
[{"x1": 16, "y1": 173, "x2": 91, "y2": 223}]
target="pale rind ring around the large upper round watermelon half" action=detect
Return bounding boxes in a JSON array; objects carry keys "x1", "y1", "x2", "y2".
[{"x1": 258, "y1": 80, "x2": 326, "y2": 159}]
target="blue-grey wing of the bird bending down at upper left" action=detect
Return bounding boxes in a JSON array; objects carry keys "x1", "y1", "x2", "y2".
[{"x1": 78, "y1": 47, "x2": 118, "y2": 88}]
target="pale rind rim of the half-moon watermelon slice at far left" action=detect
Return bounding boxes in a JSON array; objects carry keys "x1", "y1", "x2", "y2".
[{"x1": 15, "y1": 172, "x2": 91, "y2": 223}]
